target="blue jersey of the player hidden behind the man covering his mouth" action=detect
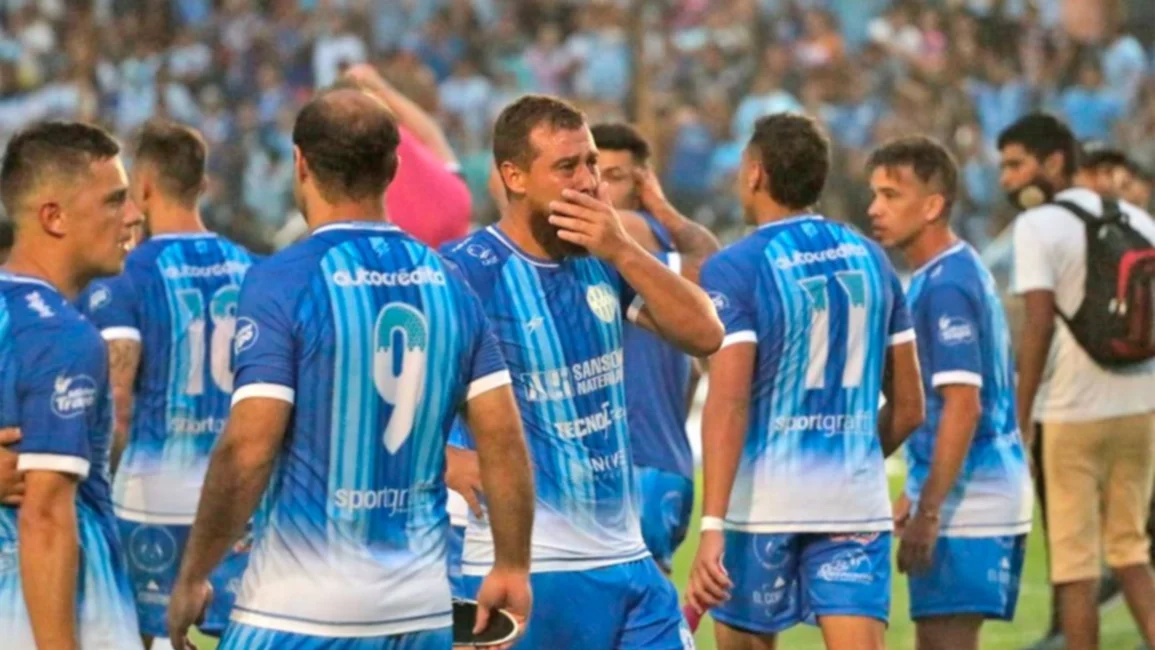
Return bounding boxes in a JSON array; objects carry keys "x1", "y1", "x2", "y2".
[{"x1": 623, "y1": 212, "x2": 694, "y2": 478}]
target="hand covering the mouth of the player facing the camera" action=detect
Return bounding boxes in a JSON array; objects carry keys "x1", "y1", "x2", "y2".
[{"x1": 550, "y1": 182, "x2": 631, "y2": 263}]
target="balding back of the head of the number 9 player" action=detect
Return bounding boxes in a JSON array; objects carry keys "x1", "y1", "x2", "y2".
[{"x1": 292, "y1": 88, "x2": 401, "y2": 203}]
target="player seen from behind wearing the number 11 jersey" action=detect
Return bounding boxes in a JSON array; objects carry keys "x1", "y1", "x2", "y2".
[{"x1": 688, "y1": 114, "x2": 923, "y2": 650}]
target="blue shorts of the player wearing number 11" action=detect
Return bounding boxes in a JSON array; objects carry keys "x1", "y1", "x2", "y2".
[{"x1": 710, "y1": 531, "x2": 891, "y2": 634}]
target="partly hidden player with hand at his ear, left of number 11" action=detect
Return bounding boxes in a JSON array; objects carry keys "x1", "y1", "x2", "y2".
[{"x1": 590, "y1": 124, "x2": 720, "y2": 575}]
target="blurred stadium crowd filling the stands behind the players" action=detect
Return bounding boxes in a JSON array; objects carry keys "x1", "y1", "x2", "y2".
[{"x1": 0, "y1": 0, "x2": 1155, "y2": 249}]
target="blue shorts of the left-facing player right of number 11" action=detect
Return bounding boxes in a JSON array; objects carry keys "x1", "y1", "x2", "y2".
[{"x1": 909, "y1": 535, "x2": 1027, "y2": 621}]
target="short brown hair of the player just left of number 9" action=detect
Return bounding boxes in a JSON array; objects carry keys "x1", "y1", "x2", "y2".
[{"x1": 133, "y1": 119, "x2": 208, "y2": 208}]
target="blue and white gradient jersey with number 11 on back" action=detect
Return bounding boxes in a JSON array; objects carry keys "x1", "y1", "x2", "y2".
[{"x1": 702, "y1": 216, "x2": 915, "y2": 532}]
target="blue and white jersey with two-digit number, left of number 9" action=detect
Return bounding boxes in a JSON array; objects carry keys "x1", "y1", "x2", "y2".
[{"x1": 79, "y1": 233, "x2": 254, "y2": 524}]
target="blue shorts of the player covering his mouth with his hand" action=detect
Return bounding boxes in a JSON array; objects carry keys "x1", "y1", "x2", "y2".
[{"x1": 465, "y1": 558, "x2": 694, "y2": 650}]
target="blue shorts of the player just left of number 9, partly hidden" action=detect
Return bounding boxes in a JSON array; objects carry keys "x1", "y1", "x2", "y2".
[{"x1": 117, "y1": 520, "x2": 252, "y2": 636}]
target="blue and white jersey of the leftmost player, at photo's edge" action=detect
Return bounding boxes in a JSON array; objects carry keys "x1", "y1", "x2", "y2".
[{"x1": 0, "y1": 272, "x2": 140, "y2": 650}]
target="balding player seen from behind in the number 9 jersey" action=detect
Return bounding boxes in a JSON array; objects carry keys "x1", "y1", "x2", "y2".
[{"x1": 169, "y1": 89, "x2": 534, "y2": 650}]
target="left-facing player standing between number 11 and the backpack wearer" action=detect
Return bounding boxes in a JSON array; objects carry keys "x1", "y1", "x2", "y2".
[{"x1": 867, "y1": 136, "x2": 1034, "y2": 650}]
